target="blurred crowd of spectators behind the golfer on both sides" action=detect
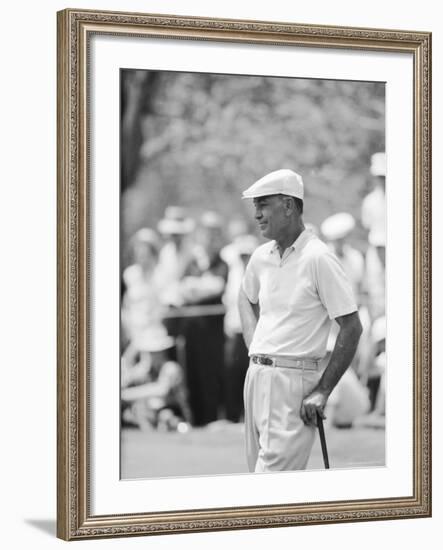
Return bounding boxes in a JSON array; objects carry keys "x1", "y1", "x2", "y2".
[{"x1": 121, "y1": 153, "x2": 386, "y2": 432}]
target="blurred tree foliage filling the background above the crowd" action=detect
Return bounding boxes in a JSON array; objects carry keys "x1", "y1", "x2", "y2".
[{"x1": 121, "y1": 71, "x2": 385, "y2": 251}]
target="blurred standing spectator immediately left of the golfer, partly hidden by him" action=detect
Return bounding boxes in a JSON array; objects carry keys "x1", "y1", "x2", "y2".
[{"x1": 224, "y1": 235, "x2": 259, "y2": 422}]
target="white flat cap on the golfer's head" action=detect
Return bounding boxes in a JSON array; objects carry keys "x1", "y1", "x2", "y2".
[{"x1": 242, "y1": 168, "x2": 303, "y2": 200}]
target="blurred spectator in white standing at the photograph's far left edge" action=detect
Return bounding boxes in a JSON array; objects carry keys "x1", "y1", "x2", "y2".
[{"x1": 121, "y1": 228, "x2": 163, "y2": 364}]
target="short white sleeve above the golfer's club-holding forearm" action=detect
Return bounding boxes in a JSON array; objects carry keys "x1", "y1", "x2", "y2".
[{"x1": 315, "y1": 252, "x2": 358, "y2": 319}]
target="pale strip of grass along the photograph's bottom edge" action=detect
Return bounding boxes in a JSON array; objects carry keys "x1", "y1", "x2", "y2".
[{"x1": 121, "y1": 422, "x2": 385, "y2": 479}]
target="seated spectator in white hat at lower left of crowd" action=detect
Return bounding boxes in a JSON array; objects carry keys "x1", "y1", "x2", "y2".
[{"x1": 121, "y1": 325, "x2": 190, "y2": 431}]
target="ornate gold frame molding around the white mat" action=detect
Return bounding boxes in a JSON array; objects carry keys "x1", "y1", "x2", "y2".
[{"x1": 57, "y1": 9, "x2": 431, "y2": 540}]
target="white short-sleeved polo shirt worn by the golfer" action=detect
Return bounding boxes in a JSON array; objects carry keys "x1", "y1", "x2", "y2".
[{"x1": 242, "y1": 230, "x2": 357, "y2": 359}]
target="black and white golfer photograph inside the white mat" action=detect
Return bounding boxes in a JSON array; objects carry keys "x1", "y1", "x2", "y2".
[{"x1": 119, "y1": 68, "x2": 389, "y2": 480}]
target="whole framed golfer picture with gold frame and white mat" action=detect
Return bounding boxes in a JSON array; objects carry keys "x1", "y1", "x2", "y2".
[{"x1": 57, "y1": 9, "x2": 431, "y2": 540}]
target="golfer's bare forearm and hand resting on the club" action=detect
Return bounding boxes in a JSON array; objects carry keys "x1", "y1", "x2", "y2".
[{"x1": 300, "y1": 311, "x2": 362, "y2": 426}]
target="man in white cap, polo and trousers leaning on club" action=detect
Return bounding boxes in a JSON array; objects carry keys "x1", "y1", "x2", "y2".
[{"x1": 239, "y1": 169, "x2": 362, "y2": 472}]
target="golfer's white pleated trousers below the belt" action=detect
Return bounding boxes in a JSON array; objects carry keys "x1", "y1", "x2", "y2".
[{"x1": 244, "y1": 362, "x2": 321, "y2": 472}]
